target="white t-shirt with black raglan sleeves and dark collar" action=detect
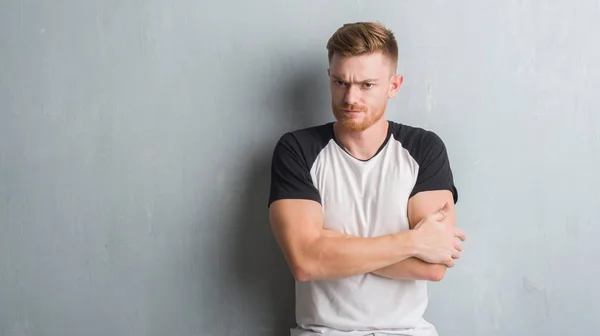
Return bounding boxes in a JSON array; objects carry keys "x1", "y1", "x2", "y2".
[{"x1": 269, "y1": 121, "x2": 458, "y2": 336}]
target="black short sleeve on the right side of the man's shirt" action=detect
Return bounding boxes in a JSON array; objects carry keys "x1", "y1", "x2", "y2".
[{"x1": 410, "y1": 132, "x2": 458, "y2": 203}]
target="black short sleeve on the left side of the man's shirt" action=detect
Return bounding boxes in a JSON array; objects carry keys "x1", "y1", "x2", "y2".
[{"x1": 268, "y1": 133, "x2": 321, "y2": 206}]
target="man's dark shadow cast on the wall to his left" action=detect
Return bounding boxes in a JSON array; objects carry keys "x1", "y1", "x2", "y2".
[{"x1": 227, "y1": 58, "x2": 328, "y2": 336}]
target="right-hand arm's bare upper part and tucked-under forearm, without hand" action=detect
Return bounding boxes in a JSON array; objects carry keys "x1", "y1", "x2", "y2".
[{"x1": 373, "y1": 190, "x2": 456, "y2": 281}]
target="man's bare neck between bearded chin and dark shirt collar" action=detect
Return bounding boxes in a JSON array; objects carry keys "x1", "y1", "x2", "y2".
[{"x1": 333, "y1": 118, "x2": 389, "y2": 160}]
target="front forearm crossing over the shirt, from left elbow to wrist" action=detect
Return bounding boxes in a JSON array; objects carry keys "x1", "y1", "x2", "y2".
[{"x1": 296, "y1": 230, "x2": 415, "y2": 280}]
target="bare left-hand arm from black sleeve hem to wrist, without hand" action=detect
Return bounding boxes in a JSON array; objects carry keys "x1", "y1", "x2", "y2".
[{"x1": 269, "y1": 199, "x2": 414, "y2": 281}]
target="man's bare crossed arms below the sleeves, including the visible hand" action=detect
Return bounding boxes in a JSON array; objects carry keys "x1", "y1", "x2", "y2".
[{"x1": 269, "y1": 190, "x2": 465, "y2": 281}]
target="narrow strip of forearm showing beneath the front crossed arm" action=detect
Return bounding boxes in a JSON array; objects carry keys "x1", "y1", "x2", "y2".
[{"x1": 372, "y1": 257, "x2": 447, "y2": 281}]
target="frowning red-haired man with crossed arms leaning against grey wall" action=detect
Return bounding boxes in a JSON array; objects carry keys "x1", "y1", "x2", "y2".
[{"x1": 269, "y1": 22, "x2": 465, "y2": 336}]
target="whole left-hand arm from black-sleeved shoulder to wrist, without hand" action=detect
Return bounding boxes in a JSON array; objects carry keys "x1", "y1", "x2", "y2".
[{"x1": 269, "y1": 133, "x2": 418, "y2": 281}]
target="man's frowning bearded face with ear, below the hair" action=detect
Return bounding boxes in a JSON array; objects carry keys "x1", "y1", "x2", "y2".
[{"x1": 327, "y1": 53, "x2": 402, "y2": 131}]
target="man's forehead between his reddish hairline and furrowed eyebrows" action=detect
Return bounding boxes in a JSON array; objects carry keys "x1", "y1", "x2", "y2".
[{"x1": 329, "y1": 52, "x2": 391, "y2": 78}]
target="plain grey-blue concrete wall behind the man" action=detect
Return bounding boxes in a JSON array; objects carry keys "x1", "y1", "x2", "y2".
[{"x1": 0, "y1": 0, "x2": 600, "y2": 336}]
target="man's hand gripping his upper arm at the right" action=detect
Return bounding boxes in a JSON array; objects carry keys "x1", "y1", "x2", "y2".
[{"x1": 413, "y1": 204, "x2": 466, "y2": 267}]
